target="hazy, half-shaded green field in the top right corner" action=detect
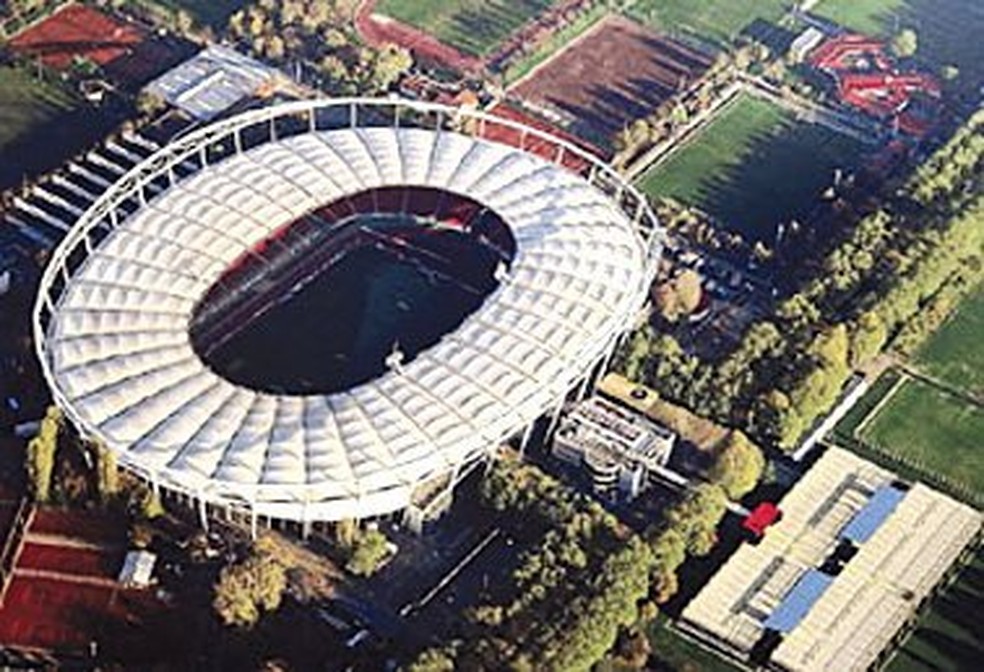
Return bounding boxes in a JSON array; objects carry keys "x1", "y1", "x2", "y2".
[{"x1": 810, "y1": 0, "x2": 984, "y2": 95}]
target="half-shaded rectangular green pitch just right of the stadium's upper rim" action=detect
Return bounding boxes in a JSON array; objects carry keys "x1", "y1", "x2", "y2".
[{"x1": 638, "y1": 94, "x2": 863, "y2": 243}]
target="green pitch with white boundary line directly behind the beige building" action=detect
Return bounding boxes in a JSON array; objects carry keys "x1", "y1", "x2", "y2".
[{"x1": 860, "y1": 380, "x2": 984, "y2": 496}]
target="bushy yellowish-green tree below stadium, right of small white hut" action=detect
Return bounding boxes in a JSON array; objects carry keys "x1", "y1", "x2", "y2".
[{"x1": 212, "y1": 541, "x2": 287, "y2": 628}]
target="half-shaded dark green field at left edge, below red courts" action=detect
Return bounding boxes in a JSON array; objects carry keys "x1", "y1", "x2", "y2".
[{"x1": 0, "y1": 67, "x2": 91, "y2": 189}]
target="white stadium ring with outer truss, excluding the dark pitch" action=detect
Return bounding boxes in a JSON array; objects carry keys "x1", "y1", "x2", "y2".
[{"x1": 33, "y1": 99, "x2": 662, "y2": 523}]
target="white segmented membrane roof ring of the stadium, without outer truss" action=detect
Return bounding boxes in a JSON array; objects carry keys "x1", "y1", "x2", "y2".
[{"x1": 40, "y1": 128, "x2": 647, "y2": 520}]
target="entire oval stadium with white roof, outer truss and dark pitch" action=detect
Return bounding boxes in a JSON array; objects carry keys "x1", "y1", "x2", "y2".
[{"x1": 33, "y1": 99, "x2": 662, "y2": 534}]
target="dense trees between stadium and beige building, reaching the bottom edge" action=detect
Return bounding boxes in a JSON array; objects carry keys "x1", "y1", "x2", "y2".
[{"x1": 408, "y1": 432, "x2": 765, "y2": 672}]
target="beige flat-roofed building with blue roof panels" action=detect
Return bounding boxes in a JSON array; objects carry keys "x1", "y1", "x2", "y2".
[{"x1": 682, "y1": 448, "x2": 981, "y2": 672}]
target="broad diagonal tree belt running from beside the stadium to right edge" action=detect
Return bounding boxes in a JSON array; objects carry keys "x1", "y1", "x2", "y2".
[{"x1": 620, "y1": 112, "x2": 984, "y2": 449}]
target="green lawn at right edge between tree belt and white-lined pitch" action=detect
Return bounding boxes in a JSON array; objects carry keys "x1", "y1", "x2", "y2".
[{"x1": 917, "y1": 287, "x2": 984, "y2": 398}]
